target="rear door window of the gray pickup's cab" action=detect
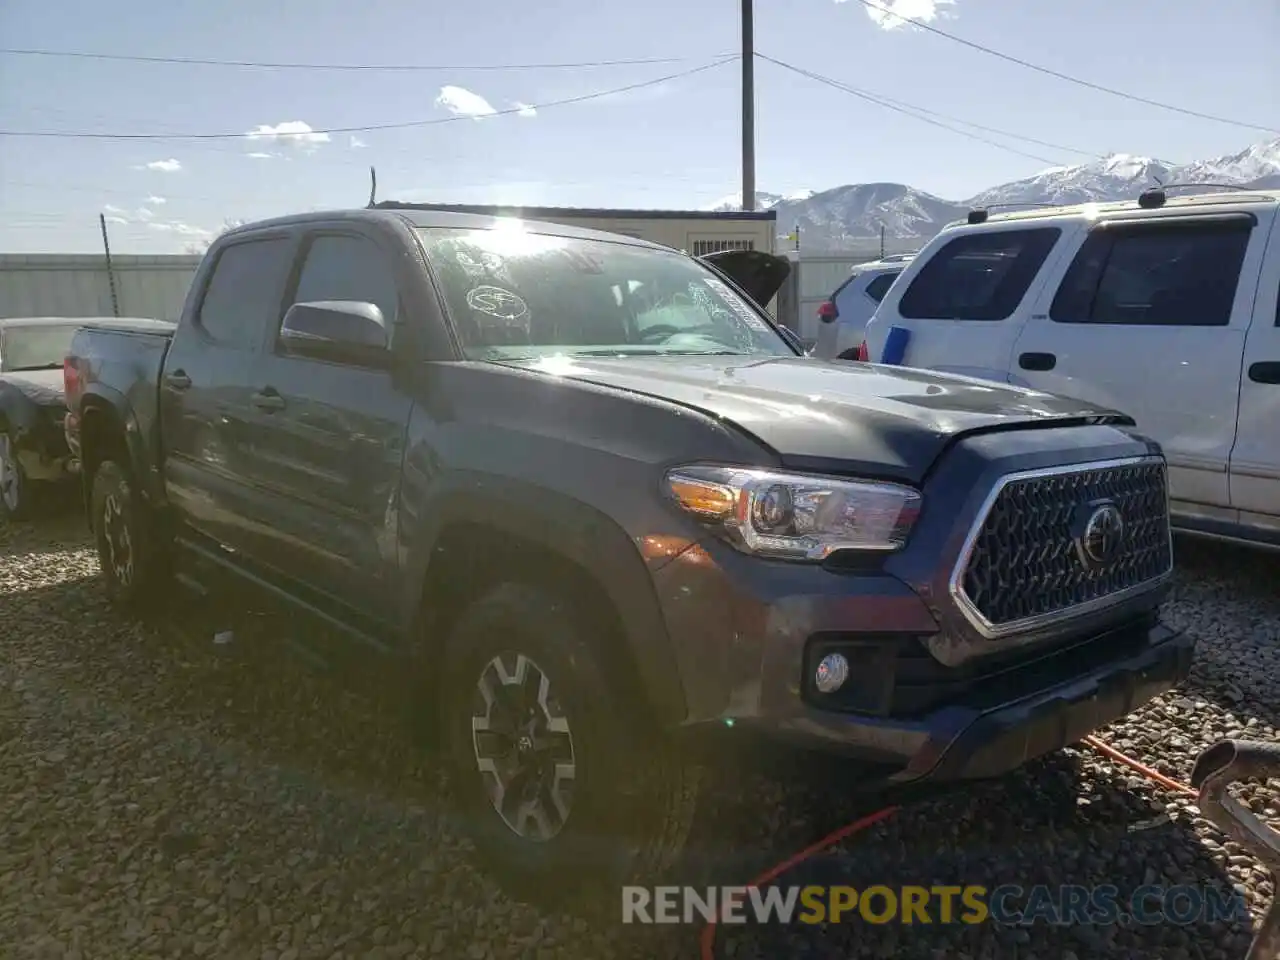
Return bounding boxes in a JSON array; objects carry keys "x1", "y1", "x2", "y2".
[{"x1": 196, "y1": 237, "x2": 291, "y2": 351}]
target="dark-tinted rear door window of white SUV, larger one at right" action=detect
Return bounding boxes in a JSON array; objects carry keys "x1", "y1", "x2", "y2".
[{"x1": 1050, "y1": 218, "x2": 1252, "y2": 326}]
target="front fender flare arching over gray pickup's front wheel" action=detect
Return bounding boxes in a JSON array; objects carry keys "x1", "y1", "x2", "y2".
[{"x1": 402, "y1": 475, "x2": 687, "y2": 726}]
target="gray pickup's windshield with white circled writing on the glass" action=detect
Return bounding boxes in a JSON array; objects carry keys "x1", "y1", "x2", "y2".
[{"x1": 420, "y1": 221, "x2": 794, "y2": 360}]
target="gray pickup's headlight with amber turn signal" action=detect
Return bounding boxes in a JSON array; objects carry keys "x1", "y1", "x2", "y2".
[{"x1": 667, "y1": 466, "x2": 920, "y2": 561}]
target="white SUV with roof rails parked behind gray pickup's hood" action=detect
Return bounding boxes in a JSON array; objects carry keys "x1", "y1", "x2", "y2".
[{"x1": 860, "y1": 184, "x2": 1280, "y2": 549}]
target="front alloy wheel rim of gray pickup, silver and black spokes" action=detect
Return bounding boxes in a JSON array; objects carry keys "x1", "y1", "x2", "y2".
[{"x1": 471, "y1": 653, "x2": 577, "y2": 842}]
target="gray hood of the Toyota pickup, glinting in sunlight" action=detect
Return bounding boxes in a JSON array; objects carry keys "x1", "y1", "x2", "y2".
[{"x1": 509, "y1": 356, "x2": 1133, "y2": 483}]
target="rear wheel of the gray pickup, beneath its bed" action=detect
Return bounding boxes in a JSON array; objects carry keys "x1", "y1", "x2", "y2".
[{"x1": 90, "y1": 460, "x2": 165, "y2": 611}]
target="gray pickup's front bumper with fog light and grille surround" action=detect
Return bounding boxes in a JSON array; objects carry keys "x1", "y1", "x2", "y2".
[{"x1": 654, "y1": 428, "x2": 1194, "y2": 785}]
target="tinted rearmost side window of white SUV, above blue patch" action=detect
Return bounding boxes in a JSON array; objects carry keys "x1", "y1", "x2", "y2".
[{"x1": 899, "y1": 227, "x2": 1061, "y2": 320}]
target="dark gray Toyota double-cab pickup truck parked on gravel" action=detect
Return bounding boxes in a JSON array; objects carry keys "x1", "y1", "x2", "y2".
[{"x1": 65, "y1": 204, "x2": 1193, "y2": 900}]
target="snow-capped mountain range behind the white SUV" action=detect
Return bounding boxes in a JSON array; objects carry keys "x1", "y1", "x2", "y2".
[{"x1": 737, "y1": 138, "x2": 1280, "y2": 251}]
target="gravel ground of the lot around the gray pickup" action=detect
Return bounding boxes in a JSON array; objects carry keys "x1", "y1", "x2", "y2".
[{"x1": 0, "y1": 506, "x2": 1280, "y2": 960}]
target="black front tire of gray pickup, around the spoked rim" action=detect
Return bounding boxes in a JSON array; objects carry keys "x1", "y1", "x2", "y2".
[{"x1": 440, "y1": 584, "x2": 700, "y2": 916}]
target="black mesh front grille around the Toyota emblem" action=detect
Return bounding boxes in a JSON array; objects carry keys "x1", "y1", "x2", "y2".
[{"x1": 956, "y1": 460, "x2": 1172, "y2": 632}]
